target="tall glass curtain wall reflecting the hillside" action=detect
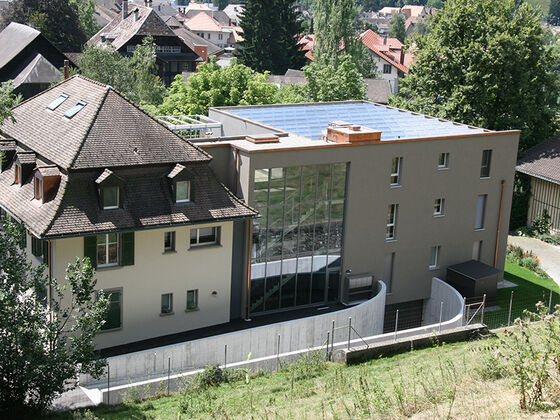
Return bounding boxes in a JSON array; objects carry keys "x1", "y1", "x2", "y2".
[{"x1": 250, "y1": 163, "x2": 347, "y2": 313}]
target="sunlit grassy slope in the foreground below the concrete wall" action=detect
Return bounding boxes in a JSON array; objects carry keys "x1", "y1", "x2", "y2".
[{"x1": 53, "y1": 338, "x2": 560, "y2": 420}]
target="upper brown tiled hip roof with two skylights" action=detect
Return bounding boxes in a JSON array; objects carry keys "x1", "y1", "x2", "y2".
[{"x1": 0, "y1": 76, "x2": 210, "y2": 169}]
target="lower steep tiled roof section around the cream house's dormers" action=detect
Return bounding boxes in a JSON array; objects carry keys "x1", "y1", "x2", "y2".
[{"x1": 0, "y1": 164, "x2": 257, "y2": 239}]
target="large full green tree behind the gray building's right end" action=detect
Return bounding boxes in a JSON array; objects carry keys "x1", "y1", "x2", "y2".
[{"x1": 391, "y1": 0, "x2": 559, "y2": 152}]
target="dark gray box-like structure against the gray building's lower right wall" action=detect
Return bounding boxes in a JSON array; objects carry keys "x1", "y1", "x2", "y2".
[{"x1": 446, "y1": 260, "x2": 501, "y2": 306}]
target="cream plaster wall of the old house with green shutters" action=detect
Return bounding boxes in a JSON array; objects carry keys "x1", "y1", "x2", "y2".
[{"x1": 47, "y1": 222, "x2": 233, "y2": 348}]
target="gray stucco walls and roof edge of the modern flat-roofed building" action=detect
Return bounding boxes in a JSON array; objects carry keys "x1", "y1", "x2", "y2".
[{"x1": 197, "y1": 104, "x2": 519, "y2": 316}]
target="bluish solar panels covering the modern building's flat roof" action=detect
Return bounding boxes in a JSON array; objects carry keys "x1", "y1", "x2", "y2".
[{"x1": 228, "y1": 103, "x2": 484, "y2": 140}]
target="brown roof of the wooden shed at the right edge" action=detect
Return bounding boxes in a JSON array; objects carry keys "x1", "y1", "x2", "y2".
[{"x1": 515, "y1": 136, "x2": 560, "y2": 184}]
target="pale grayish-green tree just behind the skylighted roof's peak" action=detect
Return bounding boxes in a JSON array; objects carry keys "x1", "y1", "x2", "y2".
[{"x1": 78, "y1": 37, "x2": 165, "y2": 107}]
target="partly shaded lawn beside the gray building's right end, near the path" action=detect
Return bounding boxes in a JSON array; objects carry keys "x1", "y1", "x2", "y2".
[{"x1": 484, "y1": 261, "x2": 560, "y2": 328}]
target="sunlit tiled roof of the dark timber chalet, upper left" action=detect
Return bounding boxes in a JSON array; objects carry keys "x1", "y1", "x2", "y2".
[{"x1": 88, "y1": 4, "x2": 175, "y2": 50}]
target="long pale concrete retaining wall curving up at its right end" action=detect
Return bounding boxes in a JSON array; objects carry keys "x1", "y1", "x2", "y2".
[{"x1": 80, "y1": 281, "x2": 386, "y2": 386}]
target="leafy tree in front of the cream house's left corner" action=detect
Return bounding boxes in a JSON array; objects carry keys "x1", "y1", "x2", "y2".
[{"x1": 0, "y1": 219, "x2": 108, "y2": 418}]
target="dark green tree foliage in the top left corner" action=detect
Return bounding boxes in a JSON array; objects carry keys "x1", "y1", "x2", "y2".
[{"x1": 0, "y1": 0, "x2": 88, "y2": 52}]
